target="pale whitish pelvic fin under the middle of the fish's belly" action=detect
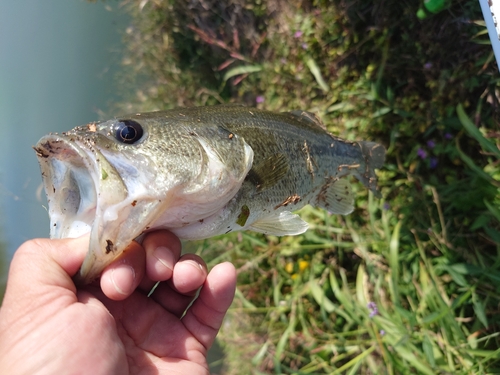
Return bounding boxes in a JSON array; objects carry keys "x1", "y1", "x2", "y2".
[{"x1": 248, "y1": 211, "x2": 309, "y2": 236}]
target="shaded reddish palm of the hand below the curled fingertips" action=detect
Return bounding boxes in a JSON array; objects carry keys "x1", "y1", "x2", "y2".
[{"x1": 91, "y1": 274, "x2": 229, "y2": 374}]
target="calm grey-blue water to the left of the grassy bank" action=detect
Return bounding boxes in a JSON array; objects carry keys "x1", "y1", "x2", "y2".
[{"x1": 0, "y1": 0, "x2": 128, "y2": 255}]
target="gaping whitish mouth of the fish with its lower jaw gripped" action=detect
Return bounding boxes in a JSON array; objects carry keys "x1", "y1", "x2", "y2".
[{"x1": 34, "y1": 134, "x2": 132, "y2": 283}]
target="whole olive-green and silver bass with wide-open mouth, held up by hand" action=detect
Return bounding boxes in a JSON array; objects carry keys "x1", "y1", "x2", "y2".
[{"x1": 34, "y1": 105, "x2": 385, "y2": 284}]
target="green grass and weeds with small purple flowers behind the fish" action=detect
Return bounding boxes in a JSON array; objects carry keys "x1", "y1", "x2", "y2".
[{"x1": 106, "y1": 0, "x2": 500, "y2": 374}]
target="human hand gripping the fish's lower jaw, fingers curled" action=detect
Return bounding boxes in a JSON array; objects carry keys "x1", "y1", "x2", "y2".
[{"x1": 0, "y1": 231, "x2": 236, "y2": 375}]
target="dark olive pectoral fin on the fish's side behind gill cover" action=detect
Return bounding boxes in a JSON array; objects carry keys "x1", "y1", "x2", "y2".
[{"x1": 247, "y1": 154, "x2": 289, "y2": 192}]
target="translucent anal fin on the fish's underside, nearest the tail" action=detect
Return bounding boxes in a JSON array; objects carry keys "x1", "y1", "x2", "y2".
[{"x1": 317, "y1": 179, "x2": 354, "y2": 215}]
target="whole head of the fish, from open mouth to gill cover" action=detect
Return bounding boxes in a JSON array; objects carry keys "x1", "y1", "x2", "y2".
[{"x1": 34, "y1": 115, "x2": 253, "y2": 284}]
